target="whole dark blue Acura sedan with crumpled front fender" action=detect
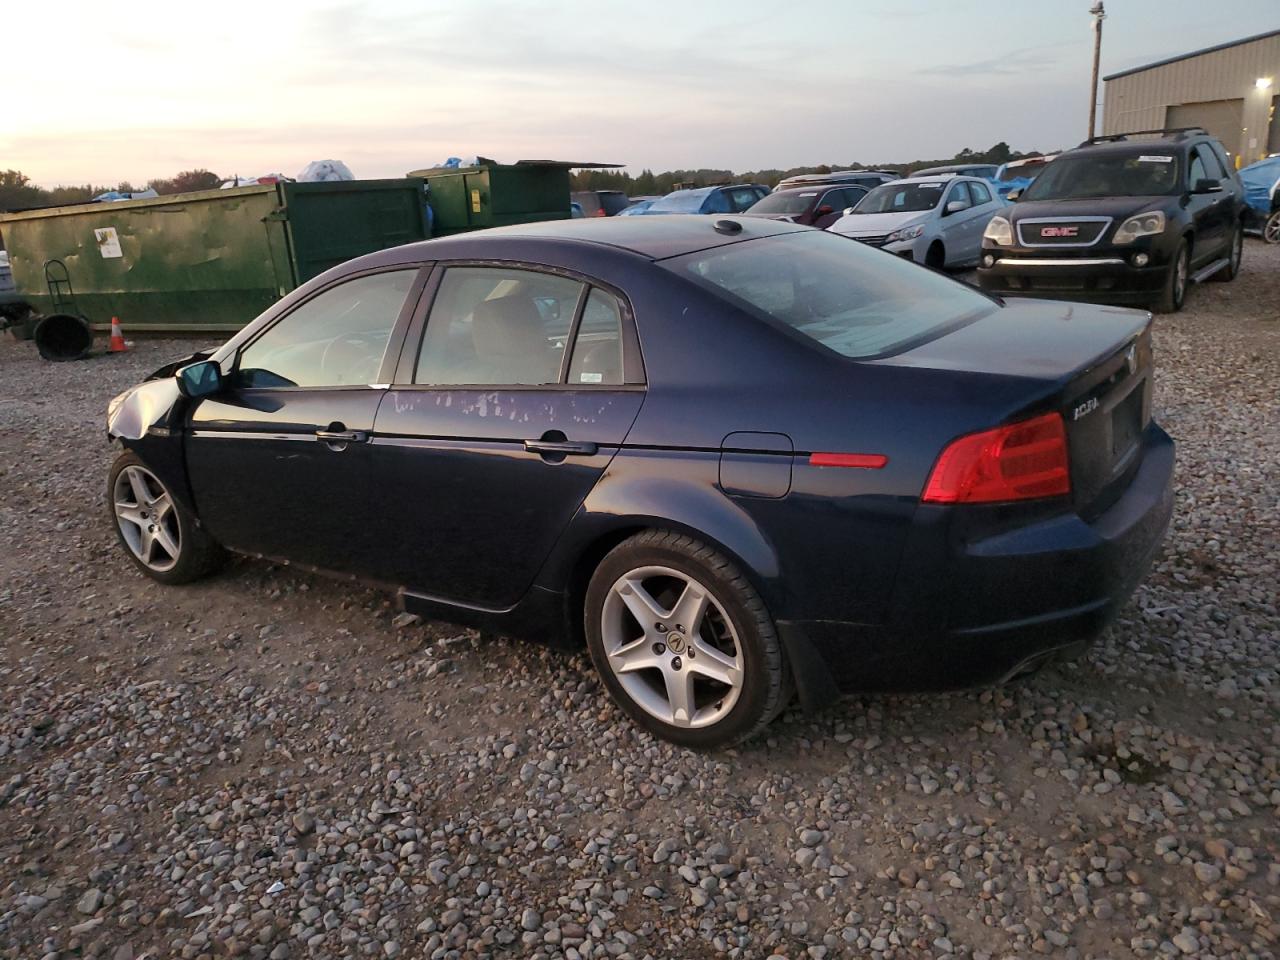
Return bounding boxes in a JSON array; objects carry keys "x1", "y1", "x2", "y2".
[{"x1": 108, "y1": 216, "x2": 1174, "y2": 746}]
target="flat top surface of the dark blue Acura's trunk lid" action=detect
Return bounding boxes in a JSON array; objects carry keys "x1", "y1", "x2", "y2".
[{"x1": 874, "y1": 298, "x2": 1151, "y2": 383}]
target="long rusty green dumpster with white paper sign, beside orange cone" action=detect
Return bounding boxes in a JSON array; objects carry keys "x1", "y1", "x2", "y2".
[{"x1": 0, "y1": 179, "x2": 428, "y2": 332}]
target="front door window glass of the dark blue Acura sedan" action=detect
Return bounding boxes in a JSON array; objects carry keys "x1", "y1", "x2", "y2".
[{"x1": 236, "y1": 268, "x2": 417, "y2": 388}]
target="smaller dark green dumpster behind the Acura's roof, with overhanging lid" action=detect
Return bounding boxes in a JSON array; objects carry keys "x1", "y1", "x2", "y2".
[{"x1": 408, "y1": 156, "x2": 617, "y2": 237}]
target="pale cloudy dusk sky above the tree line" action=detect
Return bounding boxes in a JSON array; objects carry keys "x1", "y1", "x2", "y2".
[{"x1": 0, "y1": 0, "x2": 1280, "y2": 187}]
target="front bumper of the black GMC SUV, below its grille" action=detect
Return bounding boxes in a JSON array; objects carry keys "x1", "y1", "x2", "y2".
[{"x1": 978, "y1": 250, "x2": 1169, "y2": 303}]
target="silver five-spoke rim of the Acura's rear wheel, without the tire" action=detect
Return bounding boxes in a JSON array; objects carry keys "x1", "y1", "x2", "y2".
[{"x1": 600, "y1": 566, "x2": 744, "y2": 727}]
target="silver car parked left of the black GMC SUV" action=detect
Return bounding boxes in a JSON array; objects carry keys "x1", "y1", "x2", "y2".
[{"x1": 827, "y1": 177, "x2": 1007, "y2": 269}]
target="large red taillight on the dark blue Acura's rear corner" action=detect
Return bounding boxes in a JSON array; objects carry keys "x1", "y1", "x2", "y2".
[{"x1": 922, "y1": 413, "x2": 1071, "y2": 503}]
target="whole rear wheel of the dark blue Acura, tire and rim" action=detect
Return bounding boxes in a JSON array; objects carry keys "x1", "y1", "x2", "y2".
[{"x1": 584, "y1": 530, "x2": 792, "y2": 749}]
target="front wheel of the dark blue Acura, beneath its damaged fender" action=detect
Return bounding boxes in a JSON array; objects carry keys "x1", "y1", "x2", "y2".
[{"x1": 106, "y1": 451, "x2": 227, "y2": 584}]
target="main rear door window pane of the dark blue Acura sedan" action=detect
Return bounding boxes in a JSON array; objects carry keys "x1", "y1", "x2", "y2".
[{"x1": 413, "y1": 266, "x2": 585, "y2": 387}]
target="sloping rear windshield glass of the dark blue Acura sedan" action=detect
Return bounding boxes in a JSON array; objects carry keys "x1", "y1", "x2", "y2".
[{"x1": 663, "y1": 230, "x2": 997, "y2": 360}]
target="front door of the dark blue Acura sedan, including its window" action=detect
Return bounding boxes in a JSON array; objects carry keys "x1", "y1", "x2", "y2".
[{"x1": 186, "y1": 266, "x2": 421, "y2": 573}]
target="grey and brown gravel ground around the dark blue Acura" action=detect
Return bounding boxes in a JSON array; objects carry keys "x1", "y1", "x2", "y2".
[{"x1": 0, "y1": 241, "x2": 1280, "y2": 960}]
